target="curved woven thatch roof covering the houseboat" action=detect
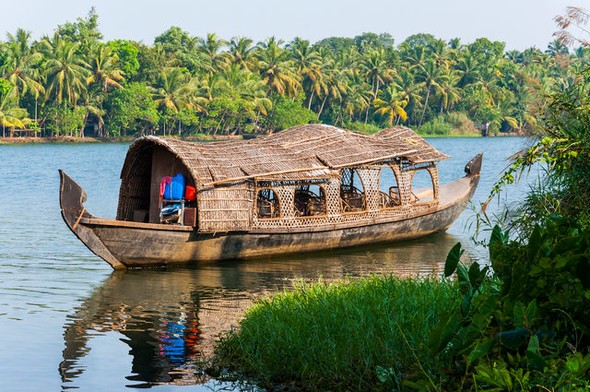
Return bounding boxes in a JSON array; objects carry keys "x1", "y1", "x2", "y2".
[{"x1": 123, "y1": 124, "x2": 448, "y2": 189}]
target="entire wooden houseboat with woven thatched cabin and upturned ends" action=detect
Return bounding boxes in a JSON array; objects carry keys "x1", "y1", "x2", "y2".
[{"x1": 60, "y1": 124, "x2": 482, "y2": 270}]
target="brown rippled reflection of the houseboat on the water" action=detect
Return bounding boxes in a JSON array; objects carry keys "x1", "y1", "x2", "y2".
[{"x1": 60, "y1": 233, "x2": 476, "y2": 389}]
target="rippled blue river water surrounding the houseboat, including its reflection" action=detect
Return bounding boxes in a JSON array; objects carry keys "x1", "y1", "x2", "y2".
[{"x1": 0, "y1": 137, "x2": 527, "y2": 391}]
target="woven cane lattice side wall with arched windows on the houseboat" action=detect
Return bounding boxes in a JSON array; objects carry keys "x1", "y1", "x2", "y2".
[{"x1": 198, "y1": 161, "x2": 438, "y2": 232}]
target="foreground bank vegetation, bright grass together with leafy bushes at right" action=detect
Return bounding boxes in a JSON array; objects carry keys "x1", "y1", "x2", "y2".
[{"x1": 218, "y1": 8, "x2": 590, "y2": 391}]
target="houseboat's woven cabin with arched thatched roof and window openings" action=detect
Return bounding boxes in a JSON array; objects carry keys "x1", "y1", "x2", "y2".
[{"x1": 117, "y1": 125, "x2": 448, "y2": 233}]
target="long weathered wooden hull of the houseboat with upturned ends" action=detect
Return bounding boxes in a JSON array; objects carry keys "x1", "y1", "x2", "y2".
[{"x1": 60, "y1": 156, "x2": 481, "y2": 270}]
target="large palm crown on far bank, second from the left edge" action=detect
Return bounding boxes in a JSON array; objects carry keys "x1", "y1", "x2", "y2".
[{"x1": 42, "y1": 37, "x2": 90, "y2": 107}]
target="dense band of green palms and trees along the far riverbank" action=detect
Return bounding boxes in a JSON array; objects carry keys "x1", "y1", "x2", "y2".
[{"x1": 0, "y1": 10, "x2": 590, "y2": 138}]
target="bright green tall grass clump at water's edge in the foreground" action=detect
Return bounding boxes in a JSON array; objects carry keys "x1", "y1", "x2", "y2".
[{"x1": 217, "y1": 276, "x2": 459, "y2": 390}]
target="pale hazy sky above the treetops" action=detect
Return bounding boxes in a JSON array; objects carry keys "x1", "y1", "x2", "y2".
[{"x1": 0, "y1": 0, "x2": 590, "y2": 51}]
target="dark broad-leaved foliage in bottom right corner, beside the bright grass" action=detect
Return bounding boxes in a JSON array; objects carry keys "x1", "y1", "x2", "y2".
[{"x1": 429, "y1": 219, "x2": 590, "y2": 391}]
